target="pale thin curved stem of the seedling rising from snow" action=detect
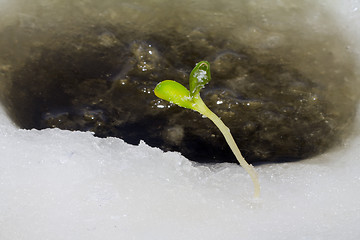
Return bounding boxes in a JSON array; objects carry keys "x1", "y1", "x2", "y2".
[{"x1": 193, "y1": 95, "x2": 260, "y2": 197}]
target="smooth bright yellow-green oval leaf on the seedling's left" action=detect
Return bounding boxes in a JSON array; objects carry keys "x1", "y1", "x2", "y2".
[{"x1": 154, "y1": 80, "x2": 193, "y2": 109}]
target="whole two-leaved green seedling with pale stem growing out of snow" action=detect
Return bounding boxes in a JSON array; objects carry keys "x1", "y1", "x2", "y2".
[{"x1": 154, "y1": 61, "x2": 260, "y2": 197}]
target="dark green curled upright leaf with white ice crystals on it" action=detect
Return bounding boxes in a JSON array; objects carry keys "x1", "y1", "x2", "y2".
[{"x1": 189, "y1": 61, "x2": 211, "y2": 97}]
